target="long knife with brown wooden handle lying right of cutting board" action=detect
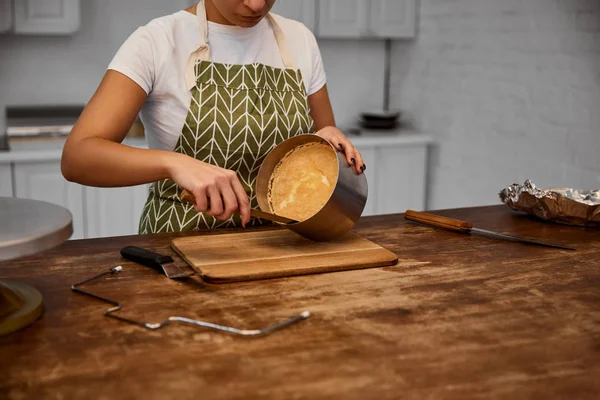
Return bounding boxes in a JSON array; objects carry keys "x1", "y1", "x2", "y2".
[{"x1": 404, "y1": 210, "x2": 575, "y2": 250}]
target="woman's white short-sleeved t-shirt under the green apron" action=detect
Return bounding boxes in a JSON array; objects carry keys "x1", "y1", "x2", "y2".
[{"x1": 108, "y1": 10, "x2": 325, "y2": 150}]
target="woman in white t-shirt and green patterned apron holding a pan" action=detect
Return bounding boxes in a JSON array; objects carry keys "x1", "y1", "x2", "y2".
[{"x1": 62, "y1": 0, "x2": 366, "y2": 233}]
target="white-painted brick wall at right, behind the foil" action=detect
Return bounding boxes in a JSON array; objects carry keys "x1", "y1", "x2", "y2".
[{"x1": 391, "y1": 0, "x2": 600, "y2": 209}]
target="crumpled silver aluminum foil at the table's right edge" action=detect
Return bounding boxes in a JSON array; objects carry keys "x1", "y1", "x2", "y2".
[{"x1": 499, "y1": 179, "x2": 600, "y2": 227}]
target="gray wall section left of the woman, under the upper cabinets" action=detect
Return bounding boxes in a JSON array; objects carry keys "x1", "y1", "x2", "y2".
[{"x1": 0, "y1": 0, "x2": 186, "y2": 122}]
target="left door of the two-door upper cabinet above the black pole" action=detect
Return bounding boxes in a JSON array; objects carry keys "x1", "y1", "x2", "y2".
[{"x1": 318, "y1": 0, "x2": 370, "y2": 38}]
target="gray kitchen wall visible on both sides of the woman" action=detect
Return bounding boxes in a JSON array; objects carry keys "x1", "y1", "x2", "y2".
[{"x1": 0, "y1": 0, "x2": 384, "y2": 133}]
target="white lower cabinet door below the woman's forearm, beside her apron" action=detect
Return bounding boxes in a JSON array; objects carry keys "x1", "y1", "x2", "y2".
[{"x1": 85, "y1": 185, "x2": 149, "y2": 238}]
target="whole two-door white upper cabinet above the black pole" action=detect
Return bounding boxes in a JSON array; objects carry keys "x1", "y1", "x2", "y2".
[{"x1": 317, "y1": 0, "x2": 417, "y2": 38}]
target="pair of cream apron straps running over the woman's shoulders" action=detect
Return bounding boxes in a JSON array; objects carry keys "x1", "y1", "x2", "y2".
[{"x1": 185, "y1": 0, "x2": 294, "y2": 90}]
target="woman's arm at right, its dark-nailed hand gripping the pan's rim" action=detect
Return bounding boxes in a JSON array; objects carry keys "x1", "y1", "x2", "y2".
[{"x1": 308, "y1": 85, "x2": 367, "y2": 174}]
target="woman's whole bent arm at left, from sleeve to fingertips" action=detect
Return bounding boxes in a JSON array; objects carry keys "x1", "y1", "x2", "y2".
[{"x1": 61, "y1": 70, "x2": 250, "y2": 224}]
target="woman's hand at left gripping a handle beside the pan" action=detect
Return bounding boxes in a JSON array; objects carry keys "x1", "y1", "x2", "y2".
[{"x1": 169, "y1": 153, "x2": 250, "y2": 227}]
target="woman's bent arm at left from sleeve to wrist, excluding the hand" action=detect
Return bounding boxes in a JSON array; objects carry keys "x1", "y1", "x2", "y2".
[{"x1": 61, "y1": 70, "x2": 171, "y2": 187}]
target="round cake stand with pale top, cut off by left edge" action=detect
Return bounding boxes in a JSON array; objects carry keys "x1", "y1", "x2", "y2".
[{"x1": 0, "y1": 197, "x2": 73, "y2": 335}]
